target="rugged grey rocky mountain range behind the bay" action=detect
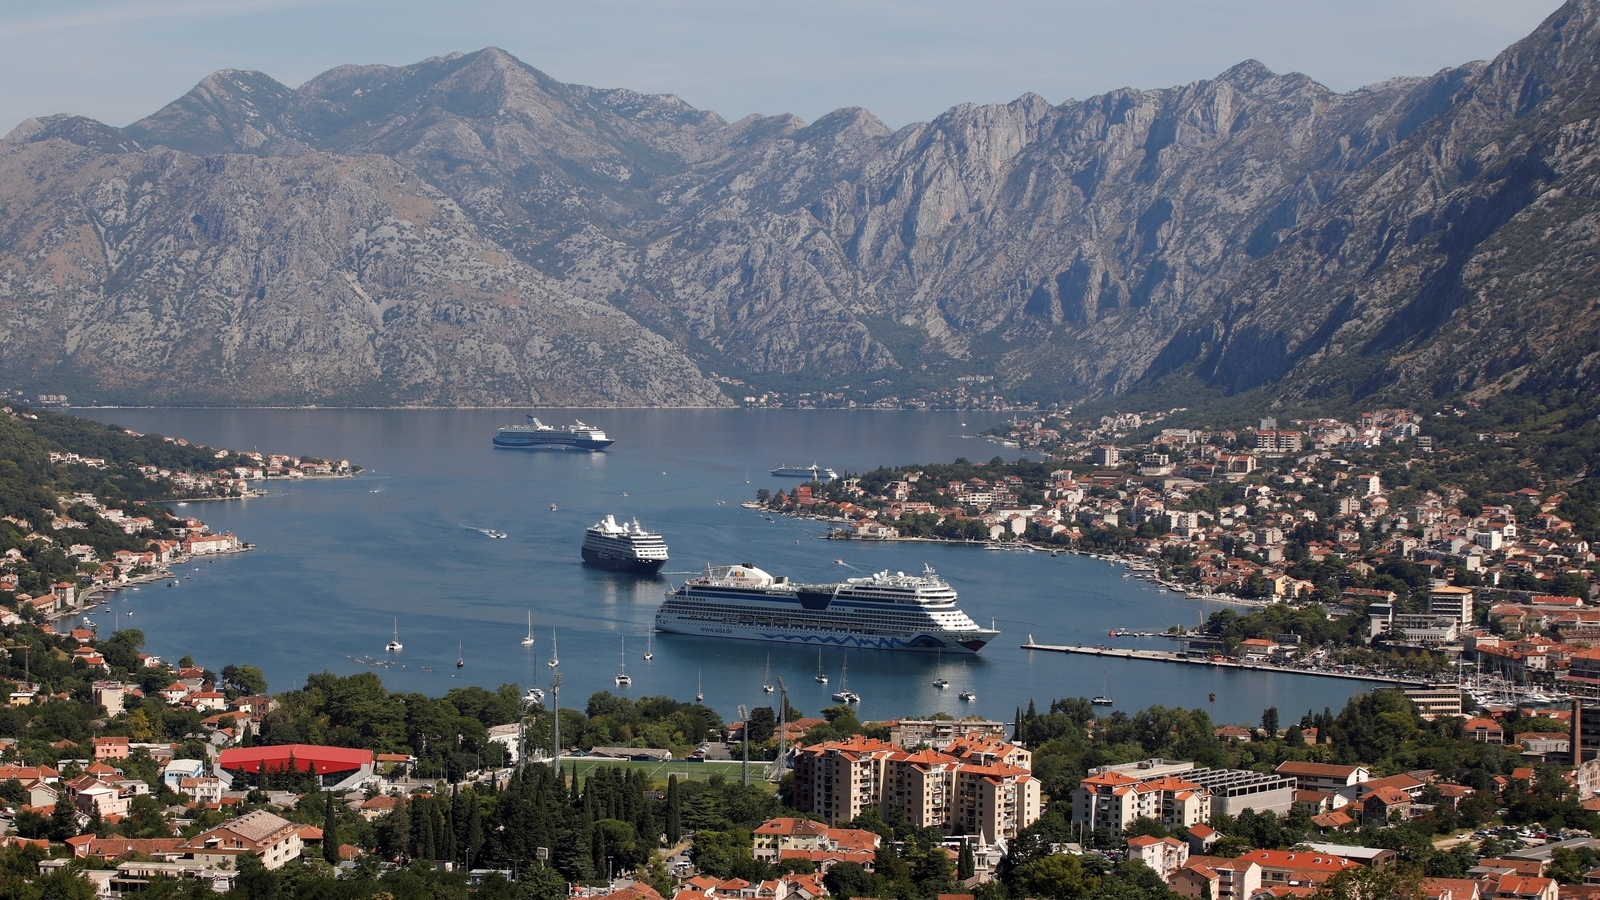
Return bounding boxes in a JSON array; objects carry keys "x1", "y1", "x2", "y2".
[{"x1": 0, "y1": 0, "x2": 1600, "y2": 405}]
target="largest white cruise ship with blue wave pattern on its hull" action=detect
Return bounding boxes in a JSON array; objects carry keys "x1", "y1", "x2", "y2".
[{"x1": 656, "y1": 564, "x2": 1000, "y2": 653}]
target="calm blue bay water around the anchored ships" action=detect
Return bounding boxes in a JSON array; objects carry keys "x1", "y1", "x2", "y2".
[{"x1": 78, "y1": 410, "x2": 1360, "y2": 722}]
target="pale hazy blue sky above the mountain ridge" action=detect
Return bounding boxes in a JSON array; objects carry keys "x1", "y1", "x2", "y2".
[{"x1": 0, "y1": 0, "x2": 1560, "y2": 133}]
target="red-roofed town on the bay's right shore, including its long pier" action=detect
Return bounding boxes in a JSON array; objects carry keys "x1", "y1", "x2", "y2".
[{"x1": 757, "y1": 403, "x2": 1600, "y2": 688}]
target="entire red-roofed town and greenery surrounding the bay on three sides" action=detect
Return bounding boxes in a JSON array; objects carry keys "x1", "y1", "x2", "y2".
[{"x1": 0, "y1": 403, "x2": 1600, "y2": 900}]
